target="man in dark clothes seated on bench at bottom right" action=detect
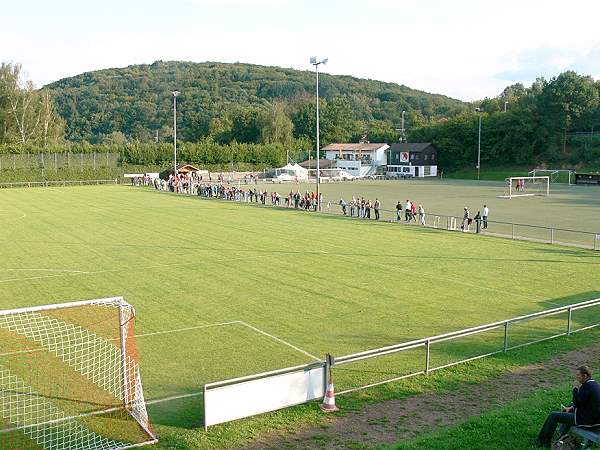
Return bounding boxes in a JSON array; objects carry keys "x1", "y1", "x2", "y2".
[{"x1": 536, "y1": 366, "x2": 600, "y2": 448}]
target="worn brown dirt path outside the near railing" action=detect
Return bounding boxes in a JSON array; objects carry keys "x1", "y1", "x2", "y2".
[{"x1": 241, "y1": 344, "x2": 600, "y2": 449}]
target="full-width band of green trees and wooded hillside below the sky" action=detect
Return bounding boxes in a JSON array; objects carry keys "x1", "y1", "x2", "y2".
[{"x1": 0, "y1": 62, "x2": 600, "y2": 172}]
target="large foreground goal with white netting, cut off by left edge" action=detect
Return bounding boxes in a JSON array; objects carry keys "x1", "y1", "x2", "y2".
[{"x1": 0, "y1": 297, "x2": 156, "y2": 450}]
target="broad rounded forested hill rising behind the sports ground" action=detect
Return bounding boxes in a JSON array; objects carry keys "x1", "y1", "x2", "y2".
[{"x1": 46, "y1": 61, "x2": 466, "y2": 143}]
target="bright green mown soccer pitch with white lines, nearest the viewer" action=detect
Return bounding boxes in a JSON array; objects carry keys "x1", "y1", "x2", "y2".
[{"x1": 0, "y1": 184, "x2": 600, "y2": 446}]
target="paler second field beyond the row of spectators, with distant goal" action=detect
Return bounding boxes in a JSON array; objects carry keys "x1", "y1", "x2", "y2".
[{"x1": 253, "y1": 178, "x2": 600, "y2": 232}]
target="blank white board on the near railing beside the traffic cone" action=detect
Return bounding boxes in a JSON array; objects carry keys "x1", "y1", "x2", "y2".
[{"x1": 204, "y1": 366, "x2": 325, "y2": 427}]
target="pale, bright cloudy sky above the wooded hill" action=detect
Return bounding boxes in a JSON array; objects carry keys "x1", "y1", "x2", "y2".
[{"x1": 0, "y1": 0, "x2": 600, "y2": 101}]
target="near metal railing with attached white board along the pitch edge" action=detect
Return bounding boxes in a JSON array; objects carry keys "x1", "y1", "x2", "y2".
[{"x1": 203, "y1": 298, "x2": 600, "y2": 429}]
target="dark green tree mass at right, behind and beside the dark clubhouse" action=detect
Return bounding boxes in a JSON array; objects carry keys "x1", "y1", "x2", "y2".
[{"x1": 409, "y1": 71, "x2": 600, "y2": 168}]
